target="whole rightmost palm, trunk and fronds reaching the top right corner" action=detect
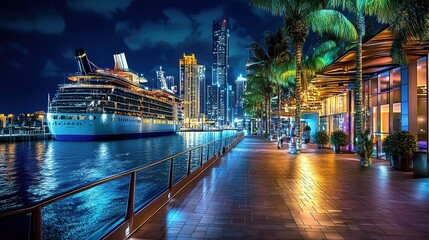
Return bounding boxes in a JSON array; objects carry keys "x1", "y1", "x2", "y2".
[{"x1": 329, "y1": 0, "x2": 429, "y2": 165}]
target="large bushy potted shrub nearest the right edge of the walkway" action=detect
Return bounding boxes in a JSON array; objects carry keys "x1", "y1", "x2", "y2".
[{"x1": 383, "y1": 131, "x2": 418, "y2": 171}]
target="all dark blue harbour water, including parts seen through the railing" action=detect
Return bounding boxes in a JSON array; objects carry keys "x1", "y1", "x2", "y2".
[{"x1": 0, "y1": 131, "x2": 235, "y2": 238}]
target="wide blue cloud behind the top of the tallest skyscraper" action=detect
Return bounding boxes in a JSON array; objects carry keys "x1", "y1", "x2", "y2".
[{"x1": 116, "y1": 8, "x2": 252, "y2": 62}]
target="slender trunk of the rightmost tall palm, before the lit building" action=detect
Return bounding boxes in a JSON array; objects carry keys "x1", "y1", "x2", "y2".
[{"x1": 354, "y1": 13, "x2": 365, "y2": 141}]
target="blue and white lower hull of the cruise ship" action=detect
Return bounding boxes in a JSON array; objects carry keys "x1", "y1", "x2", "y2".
[{"x1": 47, "y1": 113, "x2": 180, "y2": 141}]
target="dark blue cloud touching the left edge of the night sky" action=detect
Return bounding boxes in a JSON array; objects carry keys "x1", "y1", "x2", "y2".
[{"x1": 0, "y1": 8, "x2": 65, "y2": 34}]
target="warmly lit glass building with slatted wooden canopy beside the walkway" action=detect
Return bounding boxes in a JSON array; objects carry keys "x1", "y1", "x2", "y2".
[{"x1": 313, "y1": 29, "x2": 429, "y2": 158}]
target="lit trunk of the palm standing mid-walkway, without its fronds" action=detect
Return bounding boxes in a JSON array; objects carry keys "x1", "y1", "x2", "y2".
[{"x1": 295, "y1": 40, "x2": 303, "y2": 152}]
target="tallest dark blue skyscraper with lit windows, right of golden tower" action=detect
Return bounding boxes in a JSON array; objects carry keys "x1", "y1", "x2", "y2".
[{"x1": 212, "y1": 19, "x2": 231, "y2": 125}]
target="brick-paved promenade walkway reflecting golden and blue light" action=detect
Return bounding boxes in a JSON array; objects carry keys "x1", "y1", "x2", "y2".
[{"x1": 131, "y1": 136, "x2": 429, "y2": 240}]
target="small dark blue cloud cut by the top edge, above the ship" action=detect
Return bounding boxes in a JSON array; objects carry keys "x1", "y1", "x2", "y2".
[{"x1": 67, "y1": 0, "x2": 133, "y2": 18}]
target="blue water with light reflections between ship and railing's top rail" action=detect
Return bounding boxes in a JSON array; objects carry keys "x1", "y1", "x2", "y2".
[{"x1": 0, "y1": 131, "x2": 235, "y2": 211}]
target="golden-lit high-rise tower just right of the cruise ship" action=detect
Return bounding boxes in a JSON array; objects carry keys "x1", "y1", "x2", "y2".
[{"x1": 179, "y1": 54, "x2": 205, "y2": 127}]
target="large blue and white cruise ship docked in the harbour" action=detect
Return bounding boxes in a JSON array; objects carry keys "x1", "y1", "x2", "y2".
[{"x1": 47, "y1": 49, "x2": 183, "y2": 141}]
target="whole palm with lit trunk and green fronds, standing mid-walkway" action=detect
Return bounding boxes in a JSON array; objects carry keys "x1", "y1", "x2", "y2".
[{"x1": 250, "y1": 0, "x2": 357, "y2": 153}]
